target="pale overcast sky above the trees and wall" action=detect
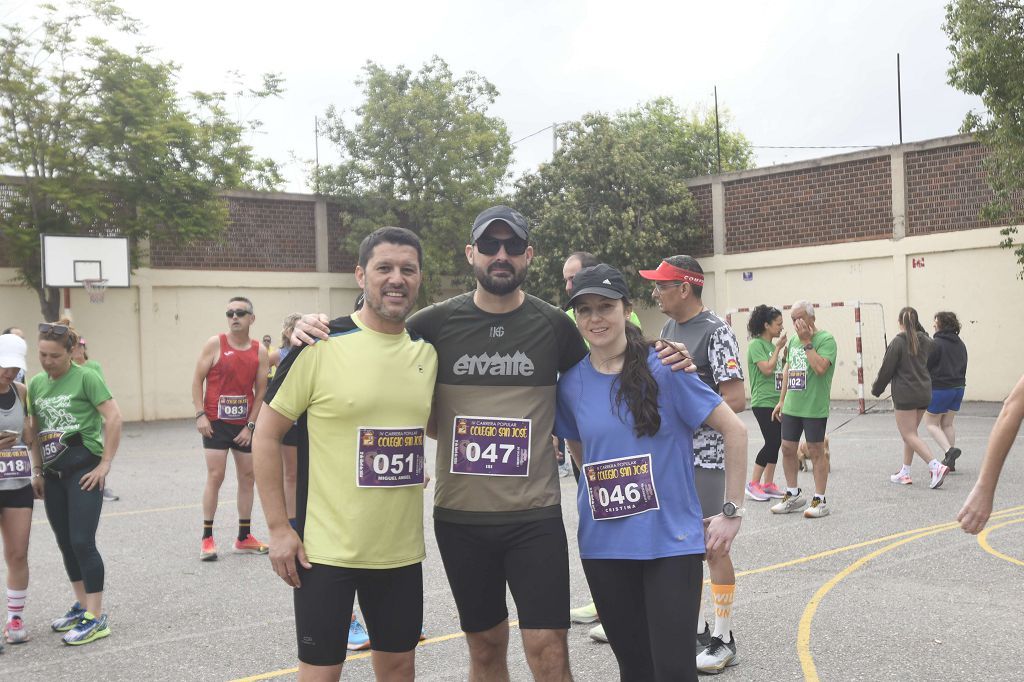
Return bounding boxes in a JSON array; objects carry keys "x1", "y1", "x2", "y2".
[{"x1": 0, "y1": 0, "x2": 980, "y2": 193}]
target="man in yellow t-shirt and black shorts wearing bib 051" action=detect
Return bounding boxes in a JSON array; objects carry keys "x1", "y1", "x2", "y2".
[{"x1": 253, "y1": 227, "x2": 437, "y2": 680}]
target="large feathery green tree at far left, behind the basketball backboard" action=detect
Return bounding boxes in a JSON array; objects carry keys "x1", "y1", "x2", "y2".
[{"x1": 0, "y1": 0, "x2": 281, "y2": 319}]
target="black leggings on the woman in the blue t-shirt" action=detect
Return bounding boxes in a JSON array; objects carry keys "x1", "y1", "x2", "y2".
[{"x1": 583, "y1": 554, "x2": 703, "y2": 682}]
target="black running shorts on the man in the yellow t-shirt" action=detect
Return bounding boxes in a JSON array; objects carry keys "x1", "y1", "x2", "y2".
[{"x1": 293, "y1": 563, "x2": 423, "y2": 666}]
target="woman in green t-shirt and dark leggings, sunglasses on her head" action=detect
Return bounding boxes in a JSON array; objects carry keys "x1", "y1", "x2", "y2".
[{"x1": 29, "y1": 319, "x2": 121, "y2": 645}]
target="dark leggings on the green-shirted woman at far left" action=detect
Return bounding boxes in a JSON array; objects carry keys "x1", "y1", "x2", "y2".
[{"x1": 43, "y1": 445, "x2": 103, "y2": 589}]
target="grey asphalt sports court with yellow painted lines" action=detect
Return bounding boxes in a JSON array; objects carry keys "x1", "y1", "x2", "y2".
[{"x1": 0, "y1": 403, "x2": 1024, "y2": 681}]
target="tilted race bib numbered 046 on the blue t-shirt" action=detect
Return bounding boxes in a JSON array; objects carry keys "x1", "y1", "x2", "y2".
[{"x1": 583, "y1": 455, "x2": 658, "y2": 521}]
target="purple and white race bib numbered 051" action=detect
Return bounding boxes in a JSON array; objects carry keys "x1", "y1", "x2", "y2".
[{"x1": 355, "y1": 426, "x2": 426, "y2": 487}]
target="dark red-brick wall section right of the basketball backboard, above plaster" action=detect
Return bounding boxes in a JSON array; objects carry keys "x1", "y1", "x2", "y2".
[{"x1": 151, "y1": 197, "x2": 316, "y2": 272}]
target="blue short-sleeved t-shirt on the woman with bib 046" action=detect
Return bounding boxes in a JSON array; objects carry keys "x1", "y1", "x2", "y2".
[{"x1": 555, "y1": 350, "x2": 722, "y2": 559}]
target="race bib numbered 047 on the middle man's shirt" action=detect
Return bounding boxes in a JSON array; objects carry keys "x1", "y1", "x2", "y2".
[{"x1": 451, "y1": 417, "x2": 530, "y2": 476}]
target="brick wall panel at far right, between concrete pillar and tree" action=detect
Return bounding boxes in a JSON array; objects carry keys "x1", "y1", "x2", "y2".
[{"x1": 903, "y1": 142, "x2": 998, "y2": 236}]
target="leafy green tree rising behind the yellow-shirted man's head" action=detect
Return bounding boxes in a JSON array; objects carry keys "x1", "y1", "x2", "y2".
[{"x1": 312, "y1": 56, "x2": 512, "y2": 298}]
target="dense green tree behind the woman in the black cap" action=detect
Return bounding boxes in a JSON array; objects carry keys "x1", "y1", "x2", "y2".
[{"x1": 515, "y1": 98, "x2": 752, "y2": 300}]
